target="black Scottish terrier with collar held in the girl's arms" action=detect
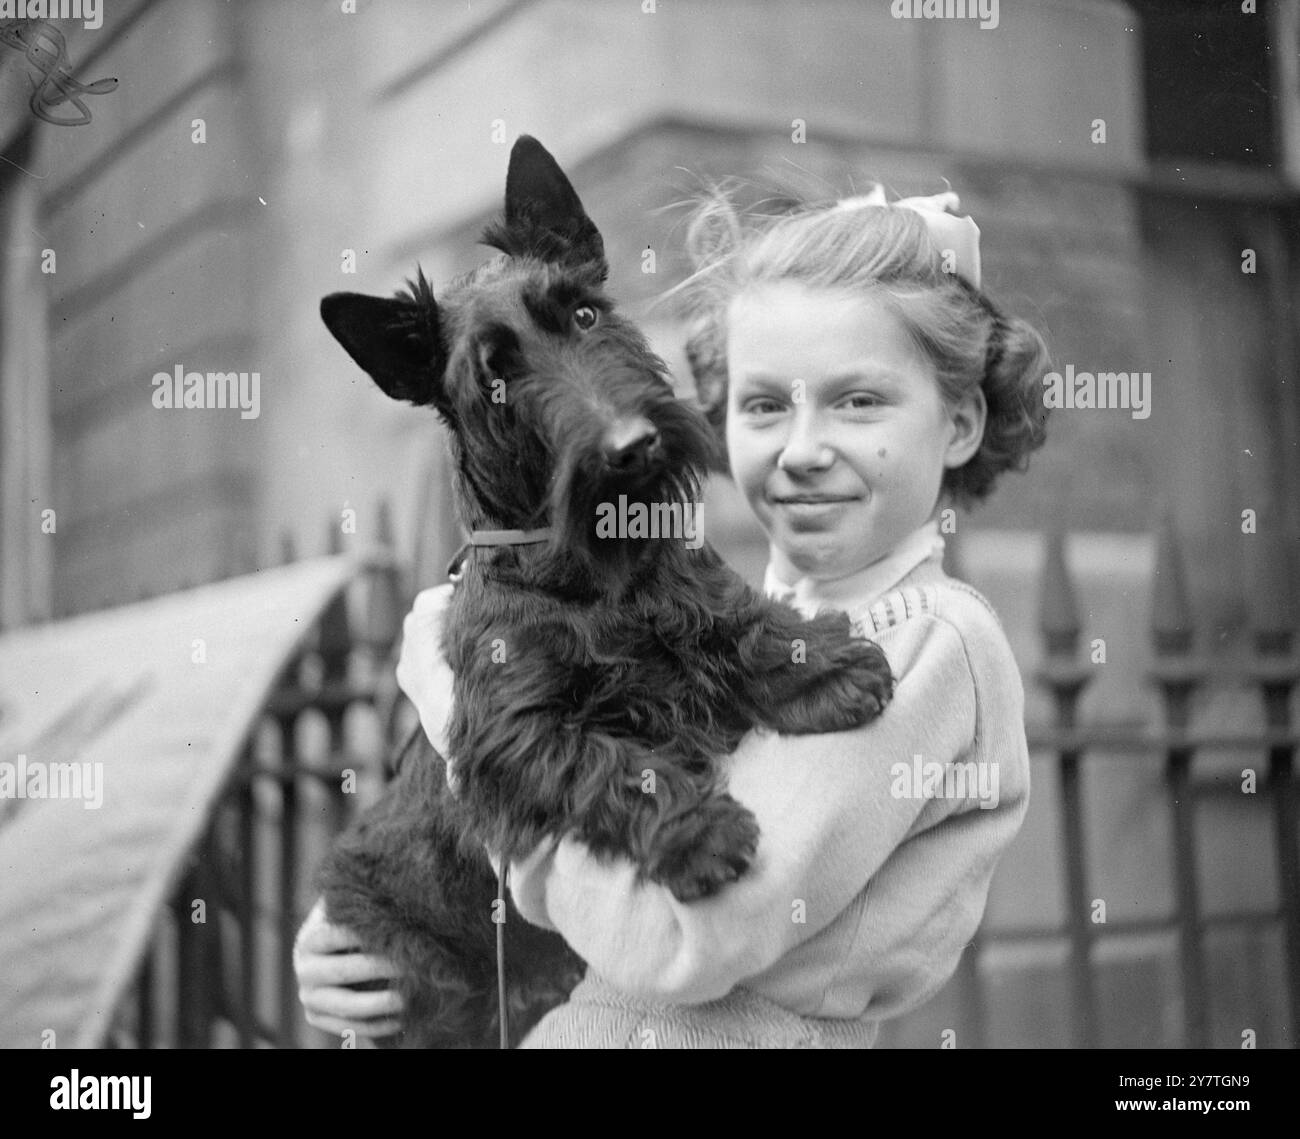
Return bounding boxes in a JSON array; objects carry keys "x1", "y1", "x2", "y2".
[{"x1": 321, "y1": 135, "x2": 892, "y2": 1045}]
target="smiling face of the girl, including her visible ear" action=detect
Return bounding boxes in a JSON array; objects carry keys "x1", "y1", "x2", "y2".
[{"x1": 727, "y1": 281, "x2": 985, "y2": 581}]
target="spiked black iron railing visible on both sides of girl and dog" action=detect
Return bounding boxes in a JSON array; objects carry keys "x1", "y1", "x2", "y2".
[{"x1": 109, "y1": 510, "x2": 1300, "y2": 1048}]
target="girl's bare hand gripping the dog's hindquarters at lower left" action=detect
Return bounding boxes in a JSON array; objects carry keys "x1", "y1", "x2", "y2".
[{"x1": 294, "y1": 898, "x2": 402, "y2": 1038}]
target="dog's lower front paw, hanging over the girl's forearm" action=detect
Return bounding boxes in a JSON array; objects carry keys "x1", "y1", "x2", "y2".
[{"x1": 644, "y1": 794, "x2": 758, "y2": 901}]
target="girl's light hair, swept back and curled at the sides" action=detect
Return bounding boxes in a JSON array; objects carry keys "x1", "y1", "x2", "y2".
[{"x1": 666, "y1": 186, "x2": 1049, "y2": 504}]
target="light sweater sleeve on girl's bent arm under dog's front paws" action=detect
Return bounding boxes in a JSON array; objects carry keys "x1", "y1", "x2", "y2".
[{"x1": 501, "y1": 615, "x2": 976, "y2": 1004}]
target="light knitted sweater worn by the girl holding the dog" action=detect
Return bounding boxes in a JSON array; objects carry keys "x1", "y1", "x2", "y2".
[{"x1": 491, "y1": 523, "x2": 1030, "y2": 1029}]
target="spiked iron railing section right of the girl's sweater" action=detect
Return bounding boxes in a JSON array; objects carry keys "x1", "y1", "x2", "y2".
[{"x1": 935, "y1": 520, "x2": 1300, "y2": 1048}]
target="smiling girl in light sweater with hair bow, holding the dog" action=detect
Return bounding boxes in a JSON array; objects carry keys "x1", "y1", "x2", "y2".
[{"x1": 299, "y1": 182, "x2": 1047, "y2": 1048}]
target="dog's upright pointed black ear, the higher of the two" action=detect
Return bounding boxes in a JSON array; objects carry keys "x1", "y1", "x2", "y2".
[{"x1": 484, "y1": 134, "x2": 608, "y2": 276}]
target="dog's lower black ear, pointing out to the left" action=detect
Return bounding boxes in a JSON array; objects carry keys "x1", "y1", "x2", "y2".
[{"x1": 321, "y1": 273, "x2": 446, "y2": 406}]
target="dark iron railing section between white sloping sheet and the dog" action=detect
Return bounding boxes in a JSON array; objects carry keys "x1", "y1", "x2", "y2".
[{"x1": 105, "y1": 506, "x2": 413, "y2": 1048}]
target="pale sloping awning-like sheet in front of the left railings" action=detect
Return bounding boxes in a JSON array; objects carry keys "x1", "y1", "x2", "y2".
[{"x1": 0, "y1": 556, "x2": 359, "y2": 1048}]
